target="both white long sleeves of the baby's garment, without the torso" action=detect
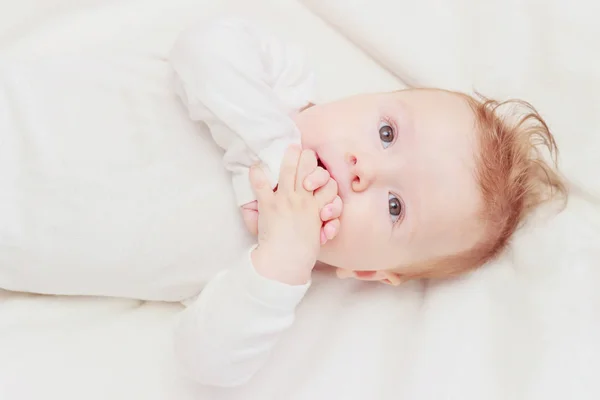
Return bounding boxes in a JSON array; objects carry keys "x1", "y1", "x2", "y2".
[{"x1": 171, "y1": 19, "x2": 313, "y2": 386}]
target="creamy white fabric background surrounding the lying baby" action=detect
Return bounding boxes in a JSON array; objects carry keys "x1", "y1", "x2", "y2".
[{"x1": 0, "y1": 0, "x2": 600, "y2": 400}]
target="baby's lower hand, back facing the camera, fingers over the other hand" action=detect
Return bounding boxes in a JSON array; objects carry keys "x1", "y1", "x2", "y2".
[{"x1": 250, "y1": 146, "x2": 324, "y2": 285}]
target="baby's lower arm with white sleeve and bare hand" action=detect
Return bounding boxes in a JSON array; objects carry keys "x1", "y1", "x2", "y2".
[{"x1": 175, "y1": 148, "x2": 337, "y2": 386}]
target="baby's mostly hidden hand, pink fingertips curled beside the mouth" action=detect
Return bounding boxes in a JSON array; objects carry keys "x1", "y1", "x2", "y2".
[{"x1": 242, "y1": 162, "x2": 343, "y2": 244}]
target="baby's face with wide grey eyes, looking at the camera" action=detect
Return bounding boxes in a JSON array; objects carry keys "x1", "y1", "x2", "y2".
[{"x1": 296, "y1": 90, "x2": 482, "y2": 272}]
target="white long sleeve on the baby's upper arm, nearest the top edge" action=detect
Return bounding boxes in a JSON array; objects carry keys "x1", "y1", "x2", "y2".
[{"x1": 170, "y1": 18, "x2": 314, "y2": 205}]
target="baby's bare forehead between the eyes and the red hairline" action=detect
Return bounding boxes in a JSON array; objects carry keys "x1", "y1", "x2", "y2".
[{"x1": 395, "y1": 90, "x2": 481, "y2": 245}]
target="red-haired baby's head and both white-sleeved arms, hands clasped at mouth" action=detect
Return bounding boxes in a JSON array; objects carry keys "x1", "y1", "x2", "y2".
[{"x1": 171, "y1": 19, "x2": 566, "y2": 386}]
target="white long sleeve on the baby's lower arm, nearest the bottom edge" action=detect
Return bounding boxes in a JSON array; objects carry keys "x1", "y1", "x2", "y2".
[{"x1": 175, "y1": 247, "x2": 310, "y2": 387}]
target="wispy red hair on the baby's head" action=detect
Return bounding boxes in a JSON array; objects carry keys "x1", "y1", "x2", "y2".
[{"x1": 400, "y1": 93, "x2": 567, "y2": 280}]
